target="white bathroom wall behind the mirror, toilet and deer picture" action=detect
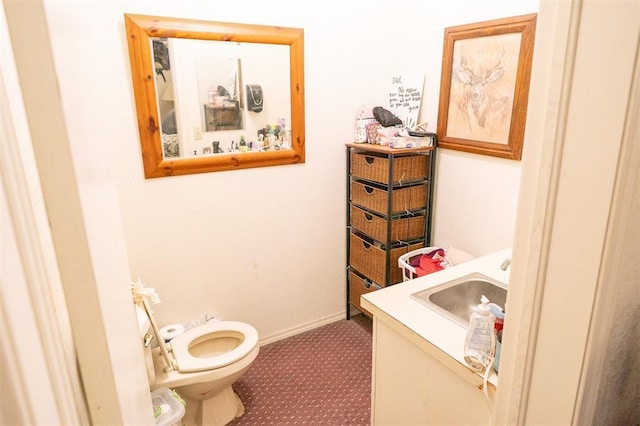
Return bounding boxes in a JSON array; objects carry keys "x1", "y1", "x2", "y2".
[{"x1": 46, "y1": 0, "x2": 538, "y2": 340}]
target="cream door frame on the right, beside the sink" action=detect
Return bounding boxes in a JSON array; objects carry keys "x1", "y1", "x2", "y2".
[{"x1": 494, "y1": 0, "x2": 640, "y2": 424}]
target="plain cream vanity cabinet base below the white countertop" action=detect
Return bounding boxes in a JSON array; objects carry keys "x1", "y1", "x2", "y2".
[{"x1": 371, "y1": 312, "x2": 496, "y2": 425}]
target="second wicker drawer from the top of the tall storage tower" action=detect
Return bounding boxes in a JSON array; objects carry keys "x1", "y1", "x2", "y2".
[{"x1": 351, "y1": 181, "x2": 428, "y2": 215}]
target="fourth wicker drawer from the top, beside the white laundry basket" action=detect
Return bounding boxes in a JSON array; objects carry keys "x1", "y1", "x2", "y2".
[{"x1": 349, "y1": 232, "x2": 423, "y2": 285}]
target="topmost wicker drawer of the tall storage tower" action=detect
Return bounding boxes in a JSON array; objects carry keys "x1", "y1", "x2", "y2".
[{"x1": 350, "y1": 151, "x2": 429, "y2": 184}]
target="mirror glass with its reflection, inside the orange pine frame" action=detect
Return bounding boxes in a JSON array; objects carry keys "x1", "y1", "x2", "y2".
[{"x1": 153, "y1": 38, "x2": 291, "y2": 158}]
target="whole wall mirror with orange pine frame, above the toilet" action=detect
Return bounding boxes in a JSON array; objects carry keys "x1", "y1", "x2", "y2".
[{"x1": 125, "y1": 14, "x2": 305, "y2": 178}]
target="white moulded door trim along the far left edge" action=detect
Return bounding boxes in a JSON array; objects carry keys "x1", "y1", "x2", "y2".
[{"x1": 0, "y1": 3, "x2": 89, "y2": 424}]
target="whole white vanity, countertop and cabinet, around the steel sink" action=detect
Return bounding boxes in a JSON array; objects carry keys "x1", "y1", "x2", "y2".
[{"x1": 361, "y1": 249, "x2": 511, "y2": 426}]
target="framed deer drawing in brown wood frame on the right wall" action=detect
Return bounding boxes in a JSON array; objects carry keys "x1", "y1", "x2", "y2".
[{"x1": 437, "y1": 14, "x2": 537, "y2": 160}]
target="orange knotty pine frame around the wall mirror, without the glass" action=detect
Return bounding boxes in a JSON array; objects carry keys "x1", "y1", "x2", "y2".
[{"x1": 124, "y1": 13, "x2": 305, "y2": 179}]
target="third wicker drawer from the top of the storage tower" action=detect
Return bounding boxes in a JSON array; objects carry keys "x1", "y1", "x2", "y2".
[{"x1": 350, "y1": 205, "x2": 425, "y2": 241}]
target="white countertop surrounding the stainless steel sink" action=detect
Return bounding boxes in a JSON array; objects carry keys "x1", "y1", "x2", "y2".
[{"x1": 361, "y1": 248, "x2": 511, "y2": 386}]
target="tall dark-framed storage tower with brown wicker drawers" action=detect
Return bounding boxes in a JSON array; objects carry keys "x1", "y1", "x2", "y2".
[{"x1": 346, "y1": 141, "x2": 436, "y2": 319}]
